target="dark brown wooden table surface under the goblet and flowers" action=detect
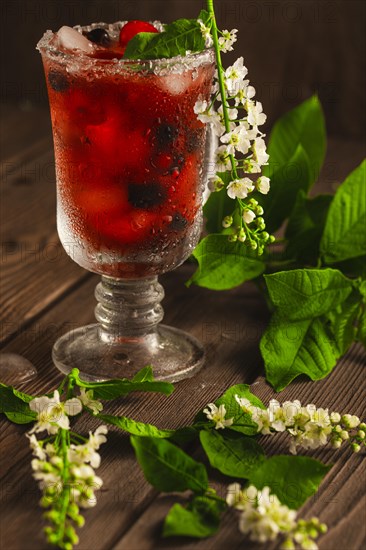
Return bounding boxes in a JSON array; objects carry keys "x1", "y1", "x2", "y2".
[{"x1": 0, "y1": 106, "x2": 366, "y2": 550}]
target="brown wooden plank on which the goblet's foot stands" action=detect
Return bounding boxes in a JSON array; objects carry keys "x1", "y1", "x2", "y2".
[{"x1": 0, "y1": 266, "x2": 267, "y2": 549}]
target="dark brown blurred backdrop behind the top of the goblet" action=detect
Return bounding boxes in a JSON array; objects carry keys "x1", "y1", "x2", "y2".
[{"x1": 0, "y1": 0, "x2": 366, "y2": 139}]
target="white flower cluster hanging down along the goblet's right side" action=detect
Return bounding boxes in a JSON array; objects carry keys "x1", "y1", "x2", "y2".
[{"x1": 194, "y1": 21, "x2": 274, "y2": 254}]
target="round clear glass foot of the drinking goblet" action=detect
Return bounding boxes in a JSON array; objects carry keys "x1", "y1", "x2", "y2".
[{"x1": 52, "y1": 324, "x2": 205, "y2": 382}]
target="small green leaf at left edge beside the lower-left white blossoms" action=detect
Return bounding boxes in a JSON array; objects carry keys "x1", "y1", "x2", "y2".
[{"x1": 0, "y1": 383, "x2": 37, "y2": 424}]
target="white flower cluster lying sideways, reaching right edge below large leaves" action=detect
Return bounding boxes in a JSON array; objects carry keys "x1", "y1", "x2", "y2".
[{"x1": 235, "y1": 395, "x2": 366, "y2": 454}]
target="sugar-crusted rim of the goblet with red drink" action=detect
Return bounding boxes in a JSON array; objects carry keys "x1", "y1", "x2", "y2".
[{"x1": 37, "y1": 21, "x2": 215, "y2": 73}]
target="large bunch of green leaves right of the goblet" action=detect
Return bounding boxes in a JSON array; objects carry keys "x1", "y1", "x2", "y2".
[{"x1": 194, "y1": 96, "x2": 366, "y2": 392}]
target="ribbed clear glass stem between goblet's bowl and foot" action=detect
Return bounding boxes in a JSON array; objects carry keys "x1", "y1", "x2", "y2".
[{"x1": 95, "y1": 276, "x2": 164, "y2": 343}]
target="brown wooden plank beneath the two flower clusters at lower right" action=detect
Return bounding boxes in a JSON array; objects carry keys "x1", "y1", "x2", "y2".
[{"x1": 113, "y1": 345, "x2": 366, "y2": 550}]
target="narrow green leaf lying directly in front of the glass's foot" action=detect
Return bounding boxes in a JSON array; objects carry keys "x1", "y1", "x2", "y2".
[{"x1": 74, "y1": 367, "x2": 174, "y2": 399}]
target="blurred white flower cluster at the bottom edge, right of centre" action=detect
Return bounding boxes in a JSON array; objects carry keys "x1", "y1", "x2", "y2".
[{"x1": 226, "y1": 483, "x2": 327, "y2": 550}]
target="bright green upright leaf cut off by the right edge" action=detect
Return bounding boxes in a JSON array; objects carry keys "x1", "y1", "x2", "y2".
[{"x1": 320, "y1": 160, "x2": 366, "y2": 264}]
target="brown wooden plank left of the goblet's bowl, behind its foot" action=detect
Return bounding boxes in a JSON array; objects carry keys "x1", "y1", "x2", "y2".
[{"x1": 0, "y1": 144, "x2": 88, "y2": 348}]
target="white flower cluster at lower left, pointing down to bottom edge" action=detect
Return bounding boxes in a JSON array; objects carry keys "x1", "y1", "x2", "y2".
[{"x1": 27, "y1": 389, "x2": 108, "y2": 550}]
